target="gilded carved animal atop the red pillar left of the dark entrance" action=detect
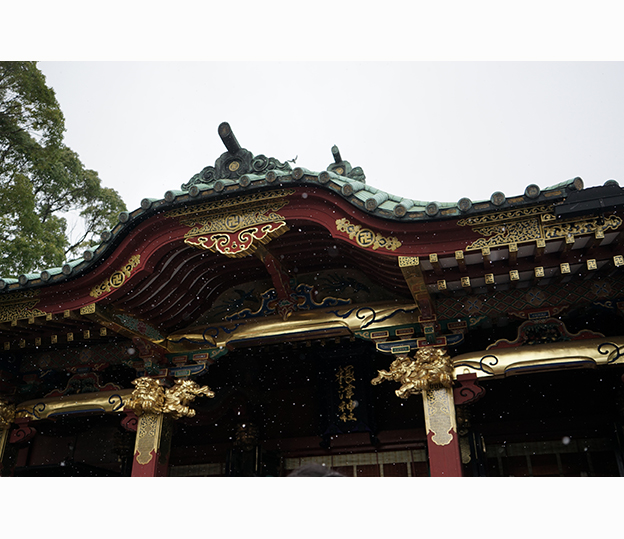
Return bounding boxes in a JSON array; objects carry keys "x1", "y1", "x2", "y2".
[{"x1": 127, "y1": 377, "x2": 214, "y2": 419}]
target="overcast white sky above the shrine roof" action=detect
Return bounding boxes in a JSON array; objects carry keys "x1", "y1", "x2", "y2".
[{"x1": 39, "y1": 61, "x2": 624, "y2": 215}]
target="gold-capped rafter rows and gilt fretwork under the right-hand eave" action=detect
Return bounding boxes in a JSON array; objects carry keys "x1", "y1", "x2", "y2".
[{"x1": 414, "y1": 207, "x2": 622, "y2": 300}]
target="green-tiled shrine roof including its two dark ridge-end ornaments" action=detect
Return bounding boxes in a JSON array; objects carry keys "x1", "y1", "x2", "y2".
[{"x1": 0, "y1": 123, "x2": 608, "y2": 293}]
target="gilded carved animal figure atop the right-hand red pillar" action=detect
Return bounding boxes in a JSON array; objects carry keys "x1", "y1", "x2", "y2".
[{"x1": 371, "y1": 348, "x2": 453, "y2": 399}]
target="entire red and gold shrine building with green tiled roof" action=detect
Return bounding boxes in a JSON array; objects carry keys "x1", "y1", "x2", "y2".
[{"x1": 0, "y1": 123, "x2": 624, "y2": 477}]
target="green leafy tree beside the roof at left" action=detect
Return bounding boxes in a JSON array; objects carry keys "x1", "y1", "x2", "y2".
[{"x1": 0, "y1": 62, "x2": 126, "y2": 277}]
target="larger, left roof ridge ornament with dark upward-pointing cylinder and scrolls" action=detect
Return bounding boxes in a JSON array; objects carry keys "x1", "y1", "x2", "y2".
[{"x1": 181, "y1": 122, "x2": 292, "y2": 191}]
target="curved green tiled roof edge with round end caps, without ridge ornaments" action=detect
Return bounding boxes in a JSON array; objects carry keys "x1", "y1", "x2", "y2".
[{"x1": 0, "y1": 168, "x2": 608, "y2": 293}]
